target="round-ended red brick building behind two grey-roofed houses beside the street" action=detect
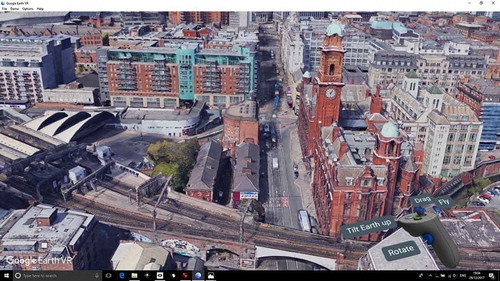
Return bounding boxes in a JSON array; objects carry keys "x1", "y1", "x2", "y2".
[{"x1": 222, "y1": 100, "x2": 259, "y2": 156}]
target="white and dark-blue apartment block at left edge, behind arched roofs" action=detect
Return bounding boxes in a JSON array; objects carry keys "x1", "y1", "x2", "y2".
[{"x1": 0, "y1": 35, "x2": 75, "y2": 102}]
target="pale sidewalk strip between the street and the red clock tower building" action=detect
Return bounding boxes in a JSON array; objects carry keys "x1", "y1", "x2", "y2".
[{"x1": 290, "y1": 128, "x2": 317, "y2": 219}]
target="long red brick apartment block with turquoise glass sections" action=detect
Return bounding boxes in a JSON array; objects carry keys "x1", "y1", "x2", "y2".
[{"x1": 97, "y1": 43, "x2": 256, "y2": 108}]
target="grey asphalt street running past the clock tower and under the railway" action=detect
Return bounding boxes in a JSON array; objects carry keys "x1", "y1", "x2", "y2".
[{"x1": 257, "y1": 21, "x2": 312, "y2": 270}]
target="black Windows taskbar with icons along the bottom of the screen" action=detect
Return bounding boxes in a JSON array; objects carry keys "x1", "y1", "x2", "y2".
[{"x1": 0, "y1": 270, "x2": 500, "y2": 281}]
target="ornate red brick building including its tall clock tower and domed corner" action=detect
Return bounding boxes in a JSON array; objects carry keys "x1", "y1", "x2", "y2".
[{"x1": 298, "y1": 24, "x2": 418, "y2": 241}]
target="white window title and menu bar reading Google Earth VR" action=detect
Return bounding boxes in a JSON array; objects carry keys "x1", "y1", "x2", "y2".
[{"x1": 0, "y1": 0, "x2": 500, "y2": 12}]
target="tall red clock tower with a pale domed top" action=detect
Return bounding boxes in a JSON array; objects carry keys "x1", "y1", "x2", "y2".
[{"x1": 315, "y1": 23, "x2": 345, "y2": 126}]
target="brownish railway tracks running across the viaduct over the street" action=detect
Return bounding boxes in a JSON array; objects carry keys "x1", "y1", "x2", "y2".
[{"x1": 6, "y1": 177, "x2": 500, "y2": 270}]
